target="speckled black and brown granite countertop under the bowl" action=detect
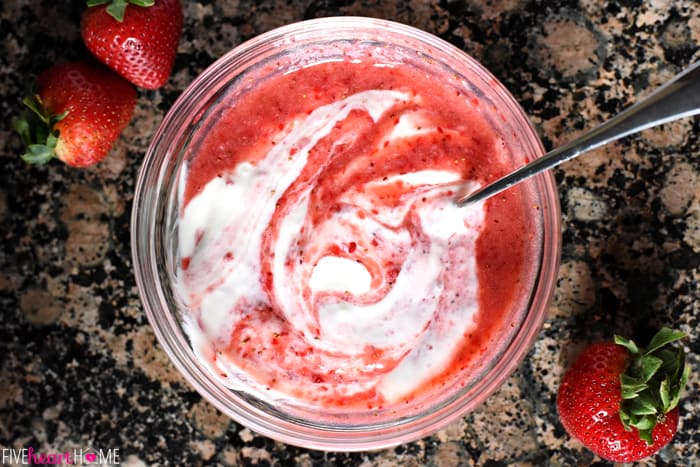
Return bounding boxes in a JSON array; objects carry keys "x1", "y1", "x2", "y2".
[{"x1": 0, "y1": 0, "x2": 700, "y2": 466}]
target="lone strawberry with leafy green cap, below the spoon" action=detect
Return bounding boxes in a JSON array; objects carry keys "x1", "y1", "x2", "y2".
[{"x1": 557, "y1": 328, "x2": 690, "y2": 462}]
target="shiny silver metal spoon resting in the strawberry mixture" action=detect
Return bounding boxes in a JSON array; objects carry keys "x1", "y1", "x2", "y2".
[{"x1": 456, "y1": 62, "x2": 700, "y2": 206}]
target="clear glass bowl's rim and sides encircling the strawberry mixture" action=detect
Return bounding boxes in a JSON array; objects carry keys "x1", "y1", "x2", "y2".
[{"x1": 131, "y1": 17, "x2": 560, "y2": 451}]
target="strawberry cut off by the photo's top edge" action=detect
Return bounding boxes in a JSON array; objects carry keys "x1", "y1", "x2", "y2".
[{"x1": 81, "y1": 0, "x2": 182, "y2": 89}]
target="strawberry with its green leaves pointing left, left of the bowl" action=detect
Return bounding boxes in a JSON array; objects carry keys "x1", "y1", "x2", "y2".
[{"x1": 14, "y1": 62, "x2": 136, "y2": 167}]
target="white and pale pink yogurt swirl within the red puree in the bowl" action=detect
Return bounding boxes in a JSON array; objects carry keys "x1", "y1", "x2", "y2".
[{"x1": 178, "y1": 90, "x2": 484, "y2": 402}]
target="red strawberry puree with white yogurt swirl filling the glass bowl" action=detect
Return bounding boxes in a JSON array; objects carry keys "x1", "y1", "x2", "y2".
[{"x1": 178, "y1": 49, "x2": 538, "y2": 408}]
